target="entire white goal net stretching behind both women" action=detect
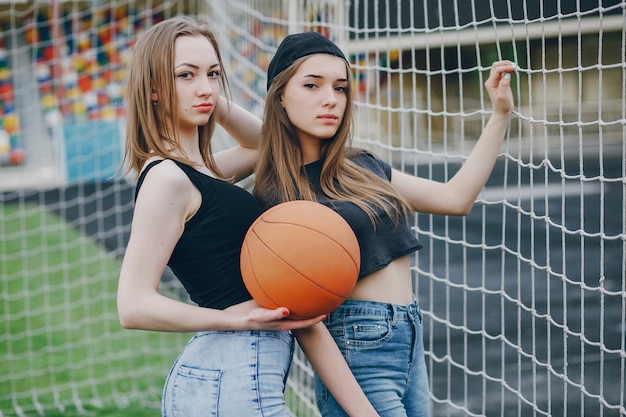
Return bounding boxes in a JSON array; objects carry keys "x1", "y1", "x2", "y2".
[{"x1": 0, "y1": 0, "x2": 626, "y2": 416}]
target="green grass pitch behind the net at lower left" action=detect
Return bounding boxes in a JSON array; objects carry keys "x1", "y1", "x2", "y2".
[{"x1": 0, "y1": 205, "x2": 189, "y2": 417}]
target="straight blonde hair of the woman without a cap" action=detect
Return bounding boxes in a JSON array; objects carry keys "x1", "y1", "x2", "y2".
[{"x1": 123, "y1": 16, "x2": 229, "y2": 178}]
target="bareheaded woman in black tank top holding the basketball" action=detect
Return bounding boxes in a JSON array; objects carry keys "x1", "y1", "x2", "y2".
[{"x1": 117, "y1": 17, "x2": 376, "y2": 417}]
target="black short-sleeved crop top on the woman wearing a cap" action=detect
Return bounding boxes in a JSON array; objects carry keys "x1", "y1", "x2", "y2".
[{"x1": 305, "y1": 152, "x2": 422, "y2": 279}]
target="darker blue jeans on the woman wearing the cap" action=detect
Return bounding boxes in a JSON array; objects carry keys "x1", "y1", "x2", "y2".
[{"x1": 315, "y1": 299, "x2": 430, "y2": 417}]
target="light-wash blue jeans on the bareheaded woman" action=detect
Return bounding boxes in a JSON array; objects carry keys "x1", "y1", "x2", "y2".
[{"x1": 161, "y1": 331, "x2": 294, "y2": 417}]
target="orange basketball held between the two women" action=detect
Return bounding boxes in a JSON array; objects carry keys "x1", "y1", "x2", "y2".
[{"x1": 240, "y1": 200, "x2": 361, "y2": 319}]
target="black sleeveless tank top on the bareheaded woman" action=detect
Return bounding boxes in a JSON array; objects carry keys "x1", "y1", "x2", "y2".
[{"x1": 135, "y1": 161, "x2": 261, "y2": 309}]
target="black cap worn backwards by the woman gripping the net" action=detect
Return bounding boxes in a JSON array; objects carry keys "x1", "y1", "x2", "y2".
[{"x1": 267, "y1": 32, "x2": 348, "y2": 90}]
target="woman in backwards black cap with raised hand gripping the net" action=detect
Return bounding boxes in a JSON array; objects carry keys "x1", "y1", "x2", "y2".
[{"x1": 253, "y1": 32, "x2": 515, "y2": 417}]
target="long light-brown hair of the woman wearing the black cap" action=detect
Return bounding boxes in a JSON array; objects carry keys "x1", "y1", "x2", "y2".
[{"x1": 253, "y1": 56, "x2": 408, "y2": 222}]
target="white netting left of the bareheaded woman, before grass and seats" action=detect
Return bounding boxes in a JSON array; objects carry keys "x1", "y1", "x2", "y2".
[{"x1": 0, "y1": 2, "x2": 196, "y2": 416}]
